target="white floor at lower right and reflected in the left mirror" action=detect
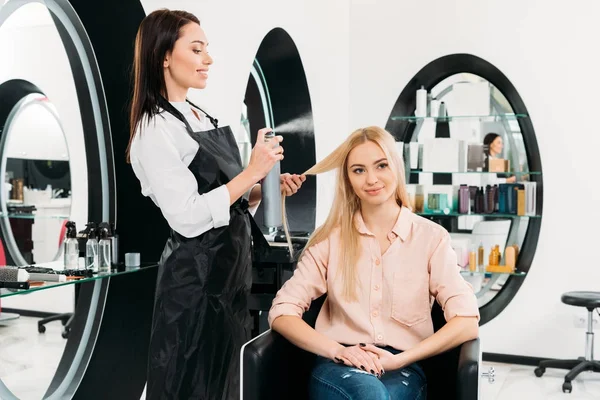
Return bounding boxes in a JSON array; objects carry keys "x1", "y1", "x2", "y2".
[{"x1": 0, "y1": 317, "x2": 600, "y2": 400}]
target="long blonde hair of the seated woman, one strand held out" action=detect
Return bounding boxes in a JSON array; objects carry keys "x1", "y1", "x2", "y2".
[{"x1": 282, "y1": 126, "x2": 411, "y2": 300}]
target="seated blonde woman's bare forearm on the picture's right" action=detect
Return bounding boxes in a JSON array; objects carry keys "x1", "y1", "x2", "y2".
[{"x1": 395, "y1": 317, "x2": 479, "y2": 368}]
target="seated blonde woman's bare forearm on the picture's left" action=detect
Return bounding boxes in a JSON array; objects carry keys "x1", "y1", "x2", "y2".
[{"x1": 272, "y1": 315, "x2": 343, "y2": 359}]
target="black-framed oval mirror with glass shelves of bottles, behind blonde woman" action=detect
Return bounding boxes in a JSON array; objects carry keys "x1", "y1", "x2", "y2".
[{"x1": 386, "y1": 54, "x2": 542, "y2": 323}]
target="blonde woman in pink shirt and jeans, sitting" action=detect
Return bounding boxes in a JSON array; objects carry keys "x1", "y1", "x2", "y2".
[{"x1": 269, "y1": 127, "x2": 479, "y2": 400}]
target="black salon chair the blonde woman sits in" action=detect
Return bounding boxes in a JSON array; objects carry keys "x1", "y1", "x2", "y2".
[{"x1": 241, "y1": 296, "x2": 480, "y2": 400}]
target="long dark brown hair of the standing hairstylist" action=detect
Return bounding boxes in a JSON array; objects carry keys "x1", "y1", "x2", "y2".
[{"x1": 127, "y1": 9, "x2": 200, "y2": 162}]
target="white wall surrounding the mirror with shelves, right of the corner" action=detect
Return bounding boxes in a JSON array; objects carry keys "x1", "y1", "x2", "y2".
[{"x1": 348, "y1": 0, "x2": 600, "y2": 358}]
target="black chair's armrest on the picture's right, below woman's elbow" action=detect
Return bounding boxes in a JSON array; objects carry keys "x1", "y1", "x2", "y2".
[{"x1": 456, "y1": 338, "x2": 481, "y2": 400}]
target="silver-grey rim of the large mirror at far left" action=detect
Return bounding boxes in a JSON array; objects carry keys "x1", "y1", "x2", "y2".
[{"x1": 0, "y1": 0, "x2": 116, "y2": 400}]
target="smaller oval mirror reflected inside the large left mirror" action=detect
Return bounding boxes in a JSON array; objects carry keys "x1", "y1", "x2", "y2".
[{"x1": 0, "y1": 94, "x2": 71, "y2": 265}]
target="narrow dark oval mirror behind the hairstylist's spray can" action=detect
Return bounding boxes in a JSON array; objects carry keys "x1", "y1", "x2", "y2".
[{"x1": 244, "y1": 28, "x2": 316, "y2": 239}]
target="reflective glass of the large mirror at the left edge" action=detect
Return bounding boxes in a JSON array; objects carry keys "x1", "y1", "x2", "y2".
[{"x1": 0, "y1": 0, "x2": 78, "y2": 399}]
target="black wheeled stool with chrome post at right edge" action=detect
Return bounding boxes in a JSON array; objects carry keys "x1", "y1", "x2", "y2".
[{"x1": 534, "y1": 292, "x2": 600, "y2": 393}]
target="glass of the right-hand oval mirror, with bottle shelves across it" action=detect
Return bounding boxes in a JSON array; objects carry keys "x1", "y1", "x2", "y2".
[{"x1": 404, "y1": 73, "x2": 540, "y2": 306}]
